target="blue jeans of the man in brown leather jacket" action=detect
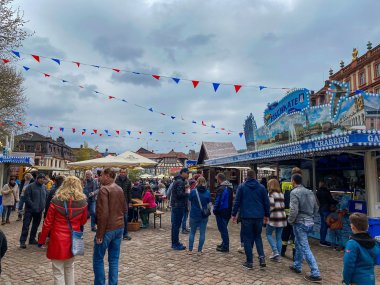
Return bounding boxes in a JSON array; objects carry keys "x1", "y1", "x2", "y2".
[{"x1": 92, "y1": 228, "x2": 124, "y2": 285}]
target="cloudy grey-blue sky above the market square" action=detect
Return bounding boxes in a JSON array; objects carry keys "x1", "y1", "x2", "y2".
[{"x1": 8, "y1": 0, "x2": 380, "y2": 152}]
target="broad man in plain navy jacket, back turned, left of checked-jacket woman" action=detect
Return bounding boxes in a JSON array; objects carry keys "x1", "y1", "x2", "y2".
[{"x1": 232, "y1": 170, "x2": 270, "y2": 269}]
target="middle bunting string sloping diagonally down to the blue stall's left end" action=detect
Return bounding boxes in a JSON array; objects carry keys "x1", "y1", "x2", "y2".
[{"x1": 0, "y1": 58, "x2": 241, "y2": 135}]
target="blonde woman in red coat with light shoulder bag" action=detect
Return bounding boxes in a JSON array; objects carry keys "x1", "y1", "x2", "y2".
[{"x1": 38, "y1": 176, "x2": 87, "y2": 285}]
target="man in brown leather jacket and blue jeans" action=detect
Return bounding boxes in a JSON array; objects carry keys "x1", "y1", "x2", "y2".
[{"x1": 93, "y1": 168, "x2": 128, "y2": 285}]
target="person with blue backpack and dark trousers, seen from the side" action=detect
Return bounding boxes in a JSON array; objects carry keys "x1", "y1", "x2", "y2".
[{"x1": 213, "y1": 173, "x2": 233, "y2": 252}]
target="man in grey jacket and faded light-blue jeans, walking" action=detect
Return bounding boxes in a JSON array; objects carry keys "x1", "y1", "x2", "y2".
[{"x1": 288, "y1": 174, "x2": 322, "y2": 282}]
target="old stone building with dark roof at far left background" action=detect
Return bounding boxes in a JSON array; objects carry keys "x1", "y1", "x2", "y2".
[{"x1": 15, "y1": 132, "x2": 74, "y2": 170}]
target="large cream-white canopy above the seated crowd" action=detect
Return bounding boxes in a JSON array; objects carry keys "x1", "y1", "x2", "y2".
[{"x1": 67, "y1": 151, "x2": 157, "y2": 169}]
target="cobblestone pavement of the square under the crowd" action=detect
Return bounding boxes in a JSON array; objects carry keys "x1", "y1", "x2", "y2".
[{"x1": 0, "y1": 212, "x2": 380, "y2": 285}]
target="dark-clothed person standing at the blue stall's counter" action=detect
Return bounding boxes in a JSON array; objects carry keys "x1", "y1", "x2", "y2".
[{"x1": 317, "y1": 181, "x2": 338, "y2": 246}]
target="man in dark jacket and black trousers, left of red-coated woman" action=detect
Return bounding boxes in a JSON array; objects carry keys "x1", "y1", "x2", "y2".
[{"x1": 20, "y1": 174, "x2": 46, "y2": 248}]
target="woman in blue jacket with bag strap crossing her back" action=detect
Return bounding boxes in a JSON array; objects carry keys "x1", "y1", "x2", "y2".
[{"x1": 189, "y1": 177, "x2": 211, "y2": 256}]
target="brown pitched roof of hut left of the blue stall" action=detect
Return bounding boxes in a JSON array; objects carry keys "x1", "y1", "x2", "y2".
[{"x1": 197, "y1": 142, "x2": 237, "y2": 164}]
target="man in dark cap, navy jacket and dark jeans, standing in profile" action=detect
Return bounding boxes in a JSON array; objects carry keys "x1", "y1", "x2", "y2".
[{"x1": 170, "y1": 168, "x2": 190, "y2": 250}]
